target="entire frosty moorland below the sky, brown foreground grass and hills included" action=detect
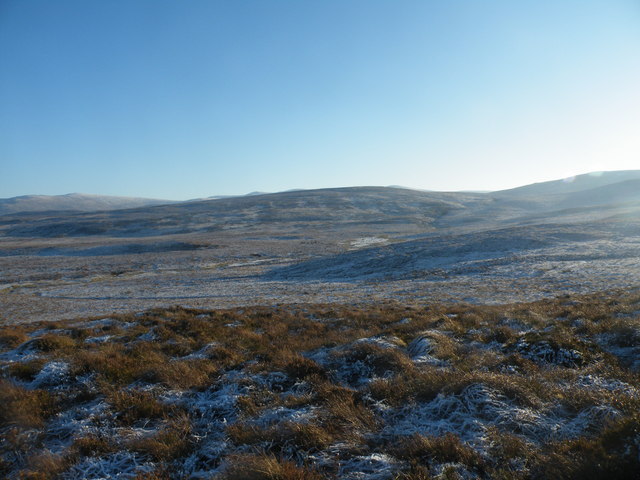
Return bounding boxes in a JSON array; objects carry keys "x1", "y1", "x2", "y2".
[{"x1": 0, "y1": 171, "x2": 640, "y2": 480}]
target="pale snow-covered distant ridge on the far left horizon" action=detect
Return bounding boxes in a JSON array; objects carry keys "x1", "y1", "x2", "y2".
[{"x1": 0, "y1": 193, "x2": 174, "y2": 215}]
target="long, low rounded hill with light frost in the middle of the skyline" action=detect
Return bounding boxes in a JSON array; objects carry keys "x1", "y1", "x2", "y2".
[{"x1": 2, "y1": 187, "x2": 479, "y2": 237}]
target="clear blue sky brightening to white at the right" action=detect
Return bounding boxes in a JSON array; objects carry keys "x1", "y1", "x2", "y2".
[{"x1": 0, "y1": 0, "x2": 640, "y2": 200}]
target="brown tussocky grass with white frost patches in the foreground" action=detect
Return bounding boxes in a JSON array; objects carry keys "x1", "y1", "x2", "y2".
[{"x1": 0, "y1": 293, "x2": 640, "y2": 480}]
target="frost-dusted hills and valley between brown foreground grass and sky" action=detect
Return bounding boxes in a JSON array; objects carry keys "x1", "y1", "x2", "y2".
[{"x1": 0, "y1": 172, "x2": 640, "y2": 322}]
